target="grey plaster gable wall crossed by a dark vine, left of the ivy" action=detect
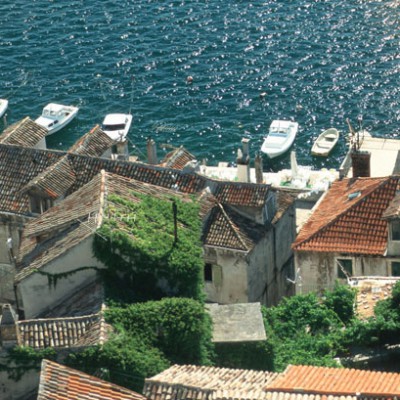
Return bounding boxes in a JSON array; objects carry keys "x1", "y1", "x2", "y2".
[{"x1": 18, "y1": 236, "x2": 104, "y2": 319}]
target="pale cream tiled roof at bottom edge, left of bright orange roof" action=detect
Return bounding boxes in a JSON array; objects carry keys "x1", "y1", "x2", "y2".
[{"x1": 143, "y1": 365, "x2": 277, "y2": 400}]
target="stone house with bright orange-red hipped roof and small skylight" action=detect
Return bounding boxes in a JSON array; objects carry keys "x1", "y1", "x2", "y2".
[{"x1": 293, "y1": 176, "x2": 400, "y2": 293}]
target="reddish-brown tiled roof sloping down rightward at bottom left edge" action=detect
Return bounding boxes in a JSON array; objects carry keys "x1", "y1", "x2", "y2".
[{"x1": 37, "y1": 360, "x2": 146, "y2": 400}]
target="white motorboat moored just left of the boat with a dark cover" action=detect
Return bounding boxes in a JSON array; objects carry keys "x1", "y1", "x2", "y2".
[{"x1": 35, "y1": 103, "x2": 79, "y2": 135}]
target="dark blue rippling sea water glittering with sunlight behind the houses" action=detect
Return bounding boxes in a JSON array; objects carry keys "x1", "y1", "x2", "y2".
[{"x1": 0, "y1": 0, "x2": 400, "y2": 168}]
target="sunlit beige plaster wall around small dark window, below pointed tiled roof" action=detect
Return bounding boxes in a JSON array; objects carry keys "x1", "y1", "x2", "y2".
[{"x1": 204, "y1": 246, "x2": 249, "y2": 304}]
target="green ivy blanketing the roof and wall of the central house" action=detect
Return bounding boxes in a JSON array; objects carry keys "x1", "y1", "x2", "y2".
[{"x1": 93, "y1": 193, "x2": 203, "y2": 302}]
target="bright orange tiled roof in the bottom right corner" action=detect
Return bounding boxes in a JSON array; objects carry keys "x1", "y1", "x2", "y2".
[{"x1": 266, "y1": 365, "x2": 400, "y2": 398}]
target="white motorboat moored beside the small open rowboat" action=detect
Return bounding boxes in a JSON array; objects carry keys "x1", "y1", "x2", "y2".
[{"x1": 261, "y1": 120, "x2": 299, "y2": 158}]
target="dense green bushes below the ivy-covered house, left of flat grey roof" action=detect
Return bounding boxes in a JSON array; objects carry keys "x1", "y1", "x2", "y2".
[{"x1": 67, "y1": 298, "x2": 212, "y2": 391}]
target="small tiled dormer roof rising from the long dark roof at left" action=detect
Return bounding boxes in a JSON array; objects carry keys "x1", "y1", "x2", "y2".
[{"x1": 21, "y1": 157, "x2": 75, "y2": 200}]
